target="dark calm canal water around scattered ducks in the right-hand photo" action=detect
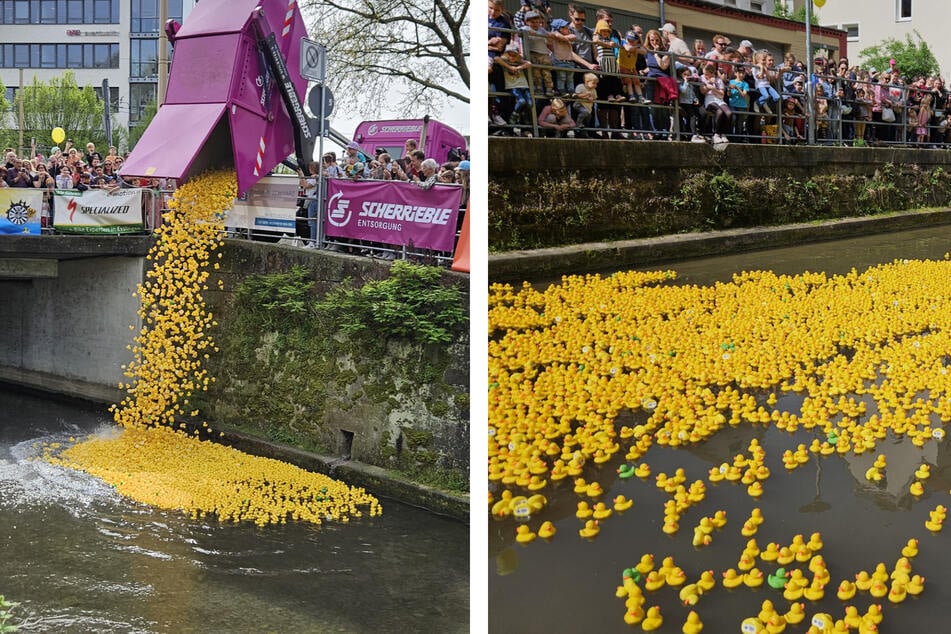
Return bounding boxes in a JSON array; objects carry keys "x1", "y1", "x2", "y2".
[{"x1": 486, "y1": 221, "x2": 951, "y2": 634}]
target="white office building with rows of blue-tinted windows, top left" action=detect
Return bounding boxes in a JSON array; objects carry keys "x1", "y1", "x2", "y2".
[{"x1": 0, "y1": 0, "x2": 197, "y2": 135}]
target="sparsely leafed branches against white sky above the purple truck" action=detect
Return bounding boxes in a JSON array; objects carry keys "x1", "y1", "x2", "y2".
[{"x1": 306, "y1": 0, "x2": 469, "y2": 116}]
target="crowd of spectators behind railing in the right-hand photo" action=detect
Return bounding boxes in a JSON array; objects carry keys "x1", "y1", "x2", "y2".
[{"x1": 488, "y1": 0, "x2": 951, "y2": 147}]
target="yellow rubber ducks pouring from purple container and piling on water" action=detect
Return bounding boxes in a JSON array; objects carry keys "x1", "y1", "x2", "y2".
[{"x1": 44, "y1": 172, "x2": 382, "y2": 524}]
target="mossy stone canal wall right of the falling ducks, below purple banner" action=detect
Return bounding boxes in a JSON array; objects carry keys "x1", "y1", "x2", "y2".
[{"x1": 192, "y1": 240, "x2": 469, "y2": 490}]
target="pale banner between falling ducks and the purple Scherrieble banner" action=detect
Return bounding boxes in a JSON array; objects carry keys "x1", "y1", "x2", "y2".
[{"x1": 225, "y1": 176, "x2": 298, "y2": 234}]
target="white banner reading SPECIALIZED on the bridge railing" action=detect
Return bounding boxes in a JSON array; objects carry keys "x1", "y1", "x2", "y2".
[{"x1": 53, "y1": 189, "x2": 144, "y2": 233}]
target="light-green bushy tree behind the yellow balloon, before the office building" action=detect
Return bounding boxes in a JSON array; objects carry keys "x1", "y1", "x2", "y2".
[{"x1": 13, "y1": 71, "x2": 105, "y2": 146}]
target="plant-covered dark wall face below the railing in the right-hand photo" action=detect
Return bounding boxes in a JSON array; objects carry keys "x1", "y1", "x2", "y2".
[{"x1": 489, "y1": 163, "x2": 951, "y2": 252}]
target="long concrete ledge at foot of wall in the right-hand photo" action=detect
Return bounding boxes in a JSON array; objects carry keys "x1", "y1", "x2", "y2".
[{"x1": 489, "y1": 208, "x2": 951, "y2": 282}]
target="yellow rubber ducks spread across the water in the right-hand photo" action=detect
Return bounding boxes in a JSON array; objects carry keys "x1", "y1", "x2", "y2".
[{"x1": 488, "y1": 257, "x2": 951, "y2": 632}]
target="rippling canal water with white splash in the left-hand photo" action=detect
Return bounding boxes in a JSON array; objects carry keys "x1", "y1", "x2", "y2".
[{"x1": 0, "y1": 386, "x2": 469, "y2": 633}]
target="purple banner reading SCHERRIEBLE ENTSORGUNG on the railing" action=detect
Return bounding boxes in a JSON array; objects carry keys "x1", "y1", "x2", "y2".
[{"x1": 324, "y1": 179, "x2": 462, "y2": 251}]
